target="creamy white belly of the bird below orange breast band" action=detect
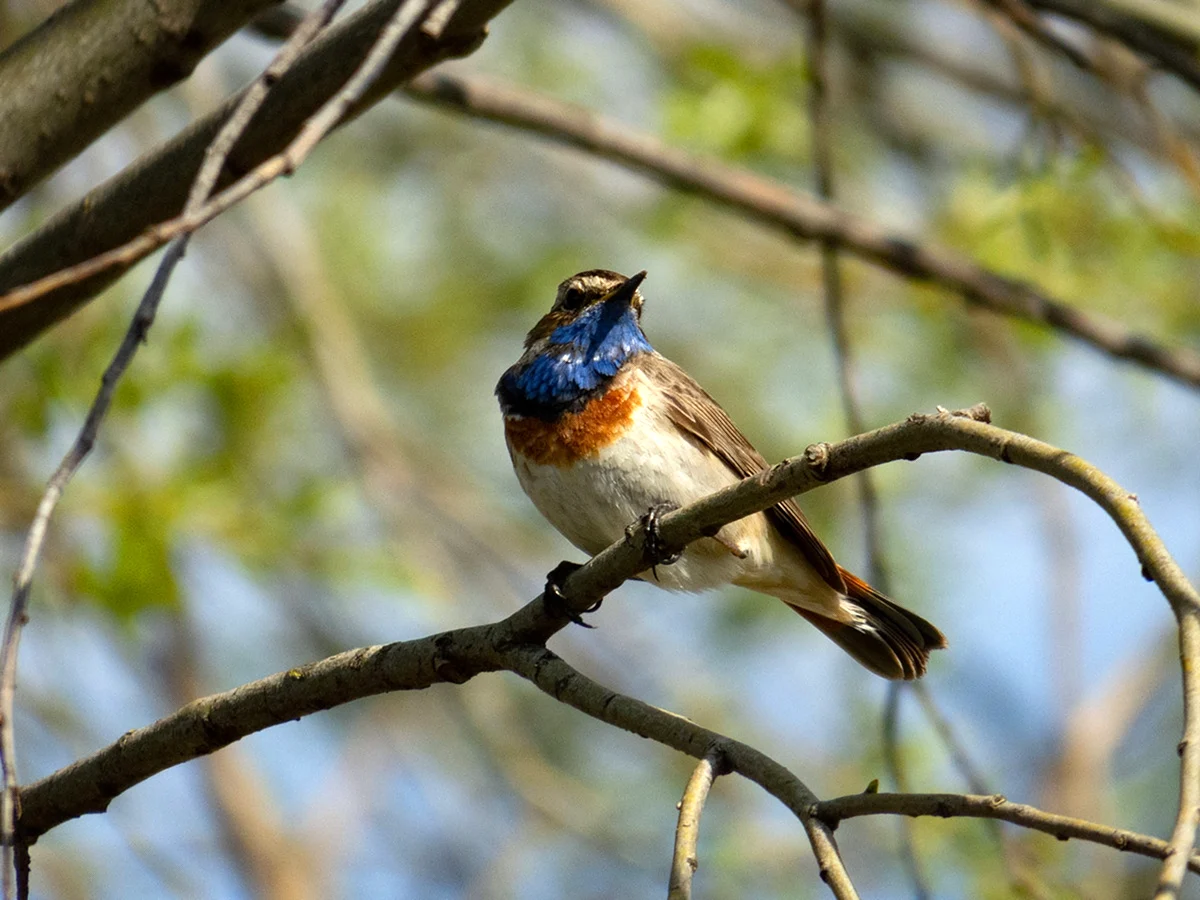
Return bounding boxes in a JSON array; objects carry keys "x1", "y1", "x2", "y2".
[{"x1": 514, "y1": 398, "x2": 791, "y2": 590}]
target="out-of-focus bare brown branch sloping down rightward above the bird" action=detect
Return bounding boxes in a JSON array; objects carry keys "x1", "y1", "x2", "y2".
[{"x1": 398, "y1": 73, "x2": 1200, "y2": 388}]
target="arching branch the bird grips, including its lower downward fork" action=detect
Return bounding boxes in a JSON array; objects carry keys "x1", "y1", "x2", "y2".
[{"x1": 18, "y1": 406, "x2": 1200, "y2": 898}]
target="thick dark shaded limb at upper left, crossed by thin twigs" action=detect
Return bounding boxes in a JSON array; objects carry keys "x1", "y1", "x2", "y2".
[{"x1": 0, "y1": 0, "x2": 511, "y2": 359}]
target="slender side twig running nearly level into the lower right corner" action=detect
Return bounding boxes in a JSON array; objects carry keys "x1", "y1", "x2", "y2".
[{"x1": 815, "y1": 793, "x2": 1200, "y2": 872}]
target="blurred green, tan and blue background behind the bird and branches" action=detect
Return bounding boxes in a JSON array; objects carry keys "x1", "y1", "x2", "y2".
[{"x1": 0, "y1": 0, "x2": 1200, "y2": 900}]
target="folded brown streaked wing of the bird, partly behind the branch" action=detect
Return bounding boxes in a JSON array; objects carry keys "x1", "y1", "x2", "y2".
[{"x1": 640, "y1": 353, "x2": 846, "y2": 594}]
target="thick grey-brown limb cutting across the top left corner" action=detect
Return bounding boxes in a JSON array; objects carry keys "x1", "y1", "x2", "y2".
[{"x1": 0, "y1": 0, "x2": 278, "y2": 210}]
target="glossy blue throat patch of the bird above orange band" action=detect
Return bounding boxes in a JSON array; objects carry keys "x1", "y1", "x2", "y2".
[{"x1": 496, "y1": 304, "x2": 654, "y2": 419}]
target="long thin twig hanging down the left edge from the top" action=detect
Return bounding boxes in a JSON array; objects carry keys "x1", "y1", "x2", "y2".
[{"x1": 0, "y1": 0, "x2": 344, "y2": 898}]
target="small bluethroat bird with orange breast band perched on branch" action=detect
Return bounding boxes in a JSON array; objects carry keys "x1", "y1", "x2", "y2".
[{"x1": 496, "y1": 269, "x2": 946, "y2": 680}]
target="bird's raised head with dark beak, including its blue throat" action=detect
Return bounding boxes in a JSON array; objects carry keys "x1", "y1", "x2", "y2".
[{"x1": 496, "y1": 269, "x2": 653, "y2": 418}]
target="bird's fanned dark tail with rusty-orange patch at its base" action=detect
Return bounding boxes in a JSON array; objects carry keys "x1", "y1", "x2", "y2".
[{"x1": 792, "y1": 566, "x2": 946, "y2": 680}]
